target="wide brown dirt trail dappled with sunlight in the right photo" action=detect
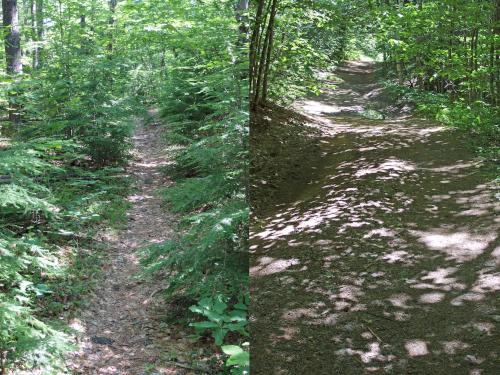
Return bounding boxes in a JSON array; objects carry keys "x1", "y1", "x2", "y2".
[{"x1": 250, "y1": 62, "x2": 500, "y2": 375}]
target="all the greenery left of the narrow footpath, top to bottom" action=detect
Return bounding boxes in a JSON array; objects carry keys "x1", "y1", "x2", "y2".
[{"x1": 0, "y1": 1, "x2": 137, "y2": 373}]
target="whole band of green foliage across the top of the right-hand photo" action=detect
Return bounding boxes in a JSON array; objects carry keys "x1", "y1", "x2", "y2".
[{"x1": 250, "y1": 0, "x2": 500, "y2": 157}]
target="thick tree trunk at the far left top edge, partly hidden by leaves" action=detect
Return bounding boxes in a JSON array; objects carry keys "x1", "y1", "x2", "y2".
[{"x1": 2, "y1": 0, "x2": 23, "y2": 123}]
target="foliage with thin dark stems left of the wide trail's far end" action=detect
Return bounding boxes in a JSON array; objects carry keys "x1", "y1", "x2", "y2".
[{"x1": 250, "y1": 0, "x2": 369, "y2": 109}]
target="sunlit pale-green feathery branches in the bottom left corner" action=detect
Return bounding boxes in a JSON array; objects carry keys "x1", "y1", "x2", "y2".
[{"x1": 0, "y1": 232, "x2": 69, "y2": 369}]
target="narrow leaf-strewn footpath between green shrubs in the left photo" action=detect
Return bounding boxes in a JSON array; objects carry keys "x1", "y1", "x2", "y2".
[{"x1": 71, "y1": 113, "x2": 186, "y2": 375}]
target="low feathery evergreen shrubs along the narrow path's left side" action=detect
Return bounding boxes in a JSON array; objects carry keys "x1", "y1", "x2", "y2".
[{"x1": 0, "y1": 137, "x2": 132, "y2": 374}]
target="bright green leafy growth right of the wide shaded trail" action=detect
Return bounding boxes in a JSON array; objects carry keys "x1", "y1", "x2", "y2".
[{"x1": 373, "y1": 0, "x2": 500, "y2": 157}]
